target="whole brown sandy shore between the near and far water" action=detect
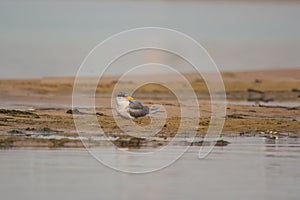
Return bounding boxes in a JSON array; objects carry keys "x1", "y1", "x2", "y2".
[{"x1": 0, "y1": 69, "x2": 300, "y2": 148}]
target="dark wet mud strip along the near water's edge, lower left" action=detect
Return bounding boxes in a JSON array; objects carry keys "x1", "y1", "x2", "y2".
[{"x1": 0, "y1": 135, "x2": 229, "y2": 149}]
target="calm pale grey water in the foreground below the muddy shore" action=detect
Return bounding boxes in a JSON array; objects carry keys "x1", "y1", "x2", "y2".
[{"x1": 0, "y1": 137, "x2": 300, "y2": 199}]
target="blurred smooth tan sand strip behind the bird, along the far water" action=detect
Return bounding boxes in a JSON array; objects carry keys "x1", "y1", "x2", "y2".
[{"x1": 0, "y1": 69, "x2": 300, "y2": 101}]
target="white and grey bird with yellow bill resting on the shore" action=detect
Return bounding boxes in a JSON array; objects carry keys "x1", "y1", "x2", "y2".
[{"x1": 116, "y1": 93, "x2": 159, "y2": 119}]
